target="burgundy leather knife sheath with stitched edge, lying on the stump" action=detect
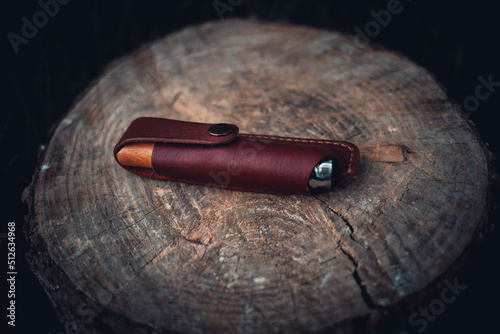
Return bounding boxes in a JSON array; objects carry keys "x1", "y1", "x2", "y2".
[{"x1": 114, "y1": 117, "x2": 359, "y2": 194}]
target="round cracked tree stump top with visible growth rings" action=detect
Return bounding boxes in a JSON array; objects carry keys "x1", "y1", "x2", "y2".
[{"x1": 23, "y1": 20, "x2": 489, "y2": 333}]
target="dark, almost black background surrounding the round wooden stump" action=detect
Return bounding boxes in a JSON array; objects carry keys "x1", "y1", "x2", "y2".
[{"x1": 0, "y1": 0, "x2": 500, "y2": 333}]
